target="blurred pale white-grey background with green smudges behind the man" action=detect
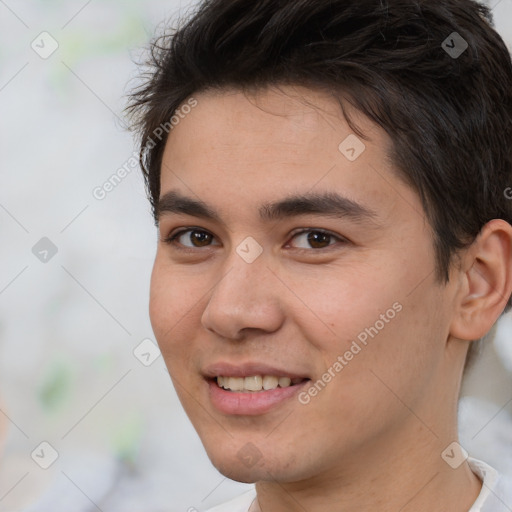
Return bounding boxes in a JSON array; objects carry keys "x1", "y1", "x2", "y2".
[{"x1": 0, "y1": 0, "x2": 512, "y2": 512}]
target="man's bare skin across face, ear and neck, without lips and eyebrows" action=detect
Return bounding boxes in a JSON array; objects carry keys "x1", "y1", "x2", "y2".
[{"x1": 150, "y1": 86, "x2": 512, "y2": 512}]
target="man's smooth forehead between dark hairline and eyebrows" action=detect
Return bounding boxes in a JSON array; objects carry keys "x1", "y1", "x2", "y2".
[{"x1": 161, "y1": 86, "x2": 421, "y2": 224}]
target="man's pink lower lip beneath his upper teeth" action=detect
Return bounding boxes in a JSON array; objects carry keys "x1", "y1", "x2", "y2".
[{"x1": 207, "y1": 380, "x2": 309, "y2": 416}]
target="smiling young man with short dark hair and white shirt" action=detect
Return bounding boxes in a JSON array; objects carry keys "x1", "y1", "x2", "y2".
[{"x1": 131, "y1": 0, "x2": 512, "y2": 512}]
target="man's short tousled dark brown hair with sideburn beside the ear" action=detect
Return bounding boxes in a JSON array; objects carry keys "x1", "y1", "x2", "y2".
[{"x1": 128, "y1": 0, "x2": 512, "y2": 363}]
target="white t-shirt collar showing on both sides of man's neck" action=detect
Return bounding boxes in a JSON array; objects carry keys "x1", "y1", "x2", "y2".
[{"x1": 206, "y1": 457, "x2": 512, "y2": 512}]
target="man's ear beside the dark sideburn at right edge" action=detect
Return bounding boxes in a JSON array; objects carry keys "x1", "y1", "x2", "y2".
[{"x1": 450, "y1": 219, "x2": 512, "y2": 341}]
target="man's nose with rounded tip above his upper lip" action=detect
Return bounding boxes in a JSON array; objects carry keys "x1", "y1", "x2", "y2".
[{"x1": 201, "y1": 253, "x2": 284, "y2": 340}]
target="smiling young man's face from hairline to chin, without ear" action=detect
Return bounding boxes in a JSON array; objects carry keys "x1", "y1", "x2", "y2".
[{"x1": 150, "y1": 87, "x2": 455, "y2": 481}]
